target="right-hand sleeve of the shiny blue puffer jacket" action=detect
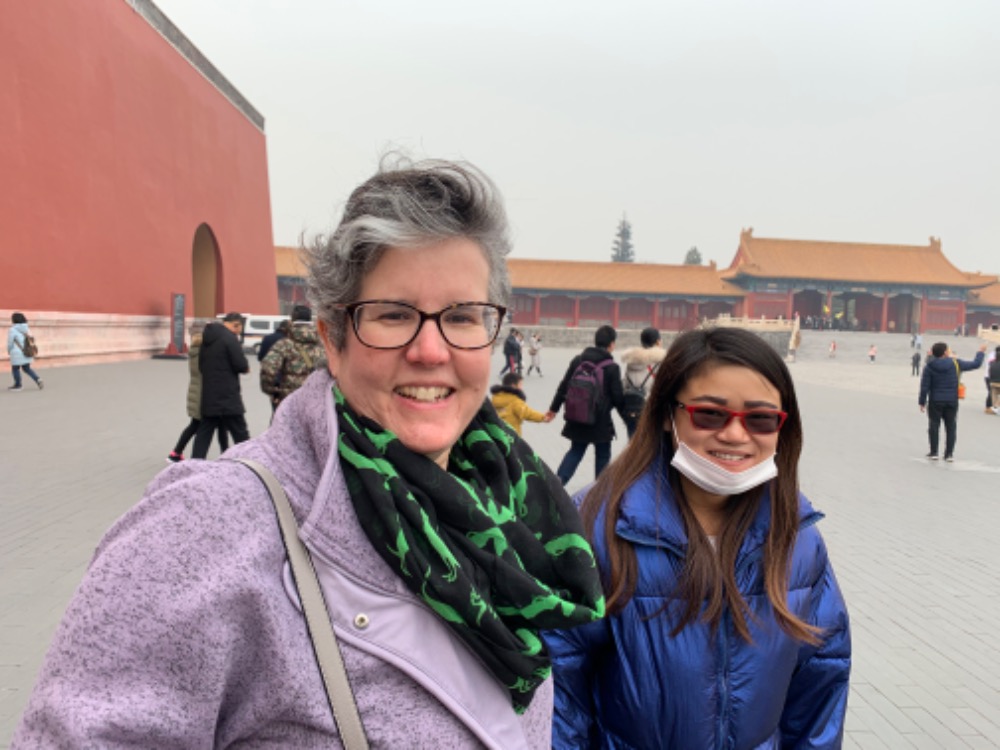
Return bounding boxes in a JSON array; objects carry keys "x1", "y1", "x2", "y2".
[{"x1": 781, "y1": 538, "x2": 851, "y2": 750}]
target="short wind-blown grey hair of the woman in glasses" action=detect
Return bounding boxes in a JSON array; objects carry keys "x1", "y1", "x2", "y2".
[{"x1": 304, "y1": 155, "x2": 511, "y2": 349}]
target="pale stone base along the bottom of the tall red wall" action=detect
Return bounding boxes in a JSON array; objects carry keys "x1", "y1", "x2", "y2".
[{"x1": 0, "y1": 310, "x2": 178, "y2": 367}]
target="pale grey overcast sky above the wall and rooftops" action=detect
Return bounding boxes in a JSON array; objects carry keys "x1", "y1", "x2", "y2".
[{"x1": 155, "y1": 0, "x2": 1000, "y2": 273}]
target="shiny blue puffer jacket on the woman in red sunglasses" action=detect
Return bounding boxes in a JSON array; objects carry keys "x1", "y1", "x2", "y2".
[{"x1": 545, "y1": 468, "x2": 851, "y2": 750}]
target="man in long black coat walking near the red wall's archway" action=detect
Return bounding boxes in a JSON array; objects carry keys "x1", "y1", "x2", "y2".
[{"x1": 191, "y1": 313, "x2": 250, "y2": 458}]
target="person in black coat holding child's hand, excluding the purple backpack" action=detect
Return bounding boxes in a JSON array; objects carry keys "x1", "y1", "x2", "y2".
[{"x1": 548, "y1": 326, "x2": 624, "y2": 485}]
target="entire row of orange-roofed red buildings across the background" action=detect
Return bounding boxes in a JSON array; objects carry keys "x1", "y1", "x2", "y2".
[{"x1": 275, "y1": 230, "x2": 1000, "y2": 333}]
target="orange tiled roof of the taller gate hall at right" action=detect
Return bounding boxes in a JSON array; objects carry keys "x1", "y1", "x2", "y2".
[{"x1": 723, "y1": 228, "x2": 995, "y2": 288}]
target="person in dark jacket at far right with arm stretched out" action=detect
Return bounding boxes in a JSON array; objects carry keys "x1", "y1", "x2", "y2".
[{"x1": 917, "y1": 341, "x2": 986, "y2": 461}]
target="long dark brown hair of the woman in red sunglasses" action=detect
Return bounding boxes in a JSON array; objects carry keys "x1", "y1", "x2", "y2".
[{"x1": 582, "y1": 328, "x2": 820, "y2": 643}]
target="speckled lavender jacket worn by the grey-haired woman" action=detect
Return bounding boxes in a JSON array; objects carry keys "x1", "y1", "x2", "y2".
[{"x1": 11, "y1": 371, "x2": 552, "y2": 750}]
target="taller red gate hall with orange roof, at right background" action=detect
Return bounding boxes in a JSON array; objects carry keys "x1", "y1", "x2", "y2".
[{"x1": 721, "y1": 229, "x2": 997, "y2": 333}]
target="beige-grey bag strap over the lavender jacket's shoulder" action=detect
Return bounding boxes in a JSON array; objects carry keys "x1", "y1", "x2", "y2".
[{"x1": 233, "y1": 458, "x2": 368, "y2": 750}]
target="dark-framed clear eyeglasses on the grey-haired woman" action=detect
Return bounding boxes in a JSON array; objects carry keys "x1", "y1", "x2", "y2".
[{"x1": 338, "y1": 299, "x2": 507, "y2": 349}]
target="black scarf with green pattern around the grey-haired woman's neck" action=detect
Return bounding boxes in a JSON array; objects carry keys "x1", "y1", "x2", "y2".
[{"x1": 333, "y1": 386, "x2": 604, "y2": 713}]
